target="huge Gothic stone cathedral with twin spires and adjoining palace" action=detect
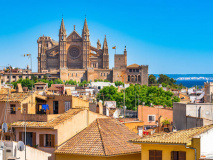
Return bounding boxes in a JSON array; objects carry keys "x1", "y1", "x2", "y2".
[{"x1": 37, "y1": 18, "x2": 148, "y2": 85}]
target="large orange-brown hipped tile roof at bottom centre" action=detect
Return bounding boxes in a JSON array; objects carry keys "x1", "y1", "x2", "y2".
[{"x1": 55, "y1": 118, "x2": 141, "y2": 156}]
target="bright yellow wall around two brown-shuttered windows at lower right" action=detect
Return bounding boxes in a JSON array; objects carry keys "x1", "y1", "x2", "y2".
[{"x1": 141, "y1": 144, "x2": 195, "y2": 160}]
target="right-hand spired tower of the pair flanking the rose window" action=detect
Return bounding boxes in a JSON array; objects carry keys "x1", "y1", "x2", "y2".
[{"x1": 82, "y1": 18, "x2": 90, "y2": 69}]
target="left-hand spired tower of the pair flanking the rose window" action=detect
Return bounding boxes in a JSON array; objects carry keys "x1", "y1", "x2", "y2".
[{"x1": 59, "y1": 18, "x2": 67, "y2": 69}]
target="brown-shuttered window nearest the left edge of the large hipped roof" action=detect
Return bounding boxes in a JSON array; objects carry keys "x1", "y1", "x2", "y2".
[{"x1": 39, "y1": 134, "x2": 55, "y2": 147}]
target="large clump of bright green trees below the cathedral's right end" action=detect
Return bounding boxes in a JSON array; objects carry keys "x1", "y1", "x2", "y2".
[{"x1": 97, "y1": 84, "x2": 180, "y2": 110}]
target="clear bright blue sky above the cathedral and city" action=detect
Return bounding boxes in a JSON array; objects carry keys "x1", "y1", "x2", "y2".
[{"x1": 0, "y1": 0, "x2": 213, "y2": 74}]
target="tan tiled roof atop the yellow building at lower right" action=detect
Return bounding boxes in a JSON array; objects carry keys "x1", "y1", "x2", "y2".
[{"x1": 130, "y1": 125, "x2": 213, "y2": 144}]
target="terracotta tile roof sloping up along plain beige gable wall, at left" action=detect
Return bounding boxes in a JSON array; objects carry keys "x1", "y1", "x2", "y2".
[{"x1": 11, "y1": 109, "x2": 83, "y2": 128}]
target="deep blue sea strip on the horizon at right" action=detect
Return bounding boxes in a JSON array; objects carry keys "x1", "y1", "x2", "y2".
[{"x1": 151, "y1": 74, "x2": 213, "y2": 88}]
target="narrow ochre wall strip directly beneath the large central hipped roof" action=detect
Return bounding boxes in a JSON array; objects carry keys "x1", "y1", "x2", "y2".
[{"x1": 55, "y1": 153, "x2": 141, "y2": 160}]
